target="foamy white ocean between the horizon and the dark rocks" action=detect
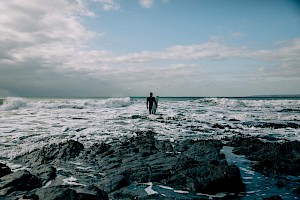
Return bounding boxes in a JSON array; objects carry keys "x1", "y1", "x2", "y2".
[{"x1": 0, "y1": 97, "x2": 300, "y2": 198}]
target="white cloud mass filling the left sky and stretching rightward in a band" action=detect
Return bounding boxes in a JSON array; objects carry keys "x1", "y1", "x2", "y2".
[{"x1": 0, "y1": 0, "x2": 300, "y2": 96}]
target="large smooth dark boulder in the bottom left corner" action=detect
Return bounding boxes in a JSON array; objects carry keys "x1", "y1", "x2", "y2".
[{"x1": 0, "y1": 170, "x2": 42, "y2": 195}]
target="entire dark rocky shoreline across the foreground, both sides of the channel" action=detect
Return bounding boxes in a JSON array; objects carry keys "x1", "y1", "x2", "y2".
[{"x1": 0, "y1": 131, "x2": 300, "y2": 200}]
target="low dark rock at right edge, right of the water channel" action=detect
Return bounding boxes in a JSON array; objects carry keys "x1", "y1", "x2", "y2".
[{"x1": 230, "y1": 137, "x2": 300, "y2": 176}]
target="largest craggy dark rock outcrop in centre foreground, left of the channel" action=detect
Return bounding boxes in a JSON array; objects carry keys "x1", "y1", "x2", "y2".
[{"x1": 88, "y1": 131, "x2": 245, "y2": 196}]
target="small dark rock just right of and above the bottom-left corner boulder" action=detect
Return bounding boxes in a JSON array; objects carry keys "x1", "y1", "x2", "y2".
[{"x1": 31, "y1": 165, "x2": 56, "y2": 185}]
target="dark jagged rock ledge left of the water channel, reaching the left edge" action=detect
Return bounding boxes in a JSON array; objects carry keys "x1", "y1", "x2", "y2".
[{"x1": 0, "y1": 131, "x2": 245, "y2": 200}]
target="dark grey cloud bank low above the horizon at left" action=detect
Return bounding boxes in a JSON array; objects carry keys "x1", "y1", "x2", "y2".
[{"x1": 0, "y1": 58, "x2": 122, "y2": 96}]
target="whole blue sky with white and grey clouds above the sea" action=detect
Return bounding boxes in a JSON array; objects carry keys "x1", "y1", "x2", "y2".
[{"x1": 0, "y1": 0, "x2": 300, "y2": 97}]
